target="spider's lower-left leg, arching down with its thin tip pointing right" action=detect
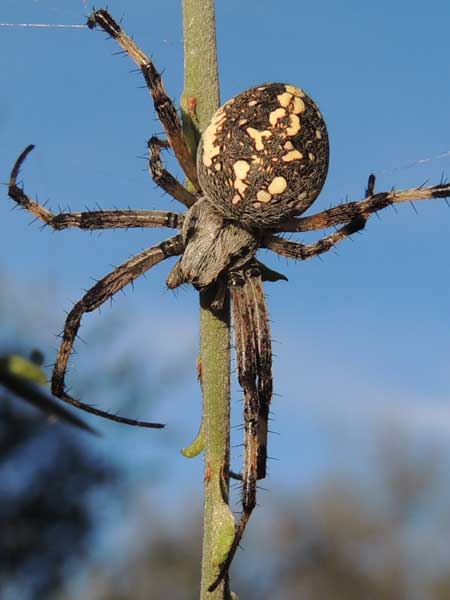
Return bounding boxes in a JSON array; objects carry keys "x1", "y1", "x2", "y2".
[{"x1": 52, "y1": 236, "x2": 183, "y2": 427}]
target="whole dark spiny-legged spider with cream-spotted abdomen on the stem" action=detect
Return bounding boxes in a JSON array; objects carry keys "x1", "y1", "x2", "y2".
[{"x1": 9, "y1": 10, "x2": 450, "y2": 591}]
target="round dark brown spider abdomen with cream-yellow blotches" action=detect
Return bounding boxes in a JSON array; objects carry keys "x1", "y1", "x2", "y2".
[{"x1": 197, "y1": 83, "x2": 329, "y2": 227}]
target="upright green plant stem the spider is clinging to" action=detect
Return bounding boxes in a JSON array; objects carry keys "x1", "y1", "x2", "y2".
[{"x1": 181, "y1": 0, "x2": 234, "y2": 600}]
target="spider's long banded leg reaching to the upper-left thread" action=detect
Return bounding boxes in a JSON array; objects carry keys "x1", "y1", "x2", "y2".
[{"x1": 87, "y1": 10, "x2": 200, "y2": 189}]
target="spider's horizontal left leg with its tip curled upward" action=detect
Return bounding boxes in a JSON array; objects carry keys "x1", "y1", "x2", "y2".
[{"x1": 8, "y1": 145, "x2": 183, "y2": 230}]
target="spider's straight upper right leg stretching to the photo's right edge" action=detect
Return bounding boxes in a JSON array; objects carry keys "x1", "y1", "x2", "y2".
[{"x1": 275, "y1": 183, "x2": 450, "y2": 231}]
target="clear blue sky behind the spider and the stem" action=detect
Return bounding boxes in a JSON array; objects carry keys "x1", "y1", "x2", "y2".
[{"x1": 0, "y1": 0, "x2": 450, "y2": 524}]
